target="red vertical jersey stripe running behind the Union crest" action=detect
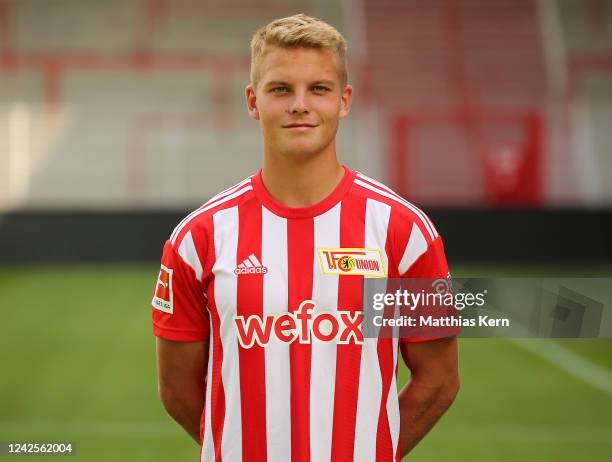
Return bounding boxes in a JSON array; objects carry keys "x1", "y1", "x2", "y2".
[{"x1": 331, "y1": 195, "x2": 366, "y2": 462}]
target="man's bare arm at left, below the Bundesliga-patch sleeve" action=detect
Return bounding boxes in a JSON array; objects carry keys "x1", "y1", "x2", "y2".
[{"x1": 157, "y1": 337, "x2": 208, "y2": 445}]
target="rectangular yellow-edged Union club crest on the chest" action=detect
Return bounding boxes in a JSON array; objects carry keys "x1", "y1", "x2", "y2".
[{"x1": 317, "y1": 247, "x2": 387, "y2": 278}]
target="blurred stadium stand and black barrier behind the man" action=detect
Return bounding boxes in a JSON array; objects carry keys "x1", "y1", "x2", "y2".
[{"x1": 0, "y1": 0, "x2": 612, "y2": 262}]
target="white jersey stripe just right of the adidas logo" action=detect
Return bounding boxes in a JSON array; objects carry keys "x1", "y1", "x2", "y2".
[{"x1": 258, "y1": 207, "x2": 291, "y2": 461}]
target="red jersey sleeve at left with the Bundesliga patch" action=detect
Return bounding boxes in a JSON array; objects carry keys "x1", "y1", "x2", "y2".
[{"x1": 151, "y1": 241, "x2": 210, "y2": 342}]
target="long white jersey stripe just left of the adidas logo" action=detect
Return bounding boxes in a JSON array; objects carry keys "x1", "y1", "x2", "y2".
[{"x1": 212, "y1": 208, "x2": 242, "y2": 460}]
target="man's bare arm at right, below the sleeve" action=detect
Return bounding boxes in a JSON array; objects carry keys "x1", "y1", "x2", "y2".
[{"x1": 399, "y1": 337, "x2": 459, "y2": 457}]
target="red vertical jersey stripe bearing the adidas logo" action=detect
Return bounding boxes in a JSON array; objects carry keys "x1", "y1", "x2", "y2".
[{"x1": 236, "y1": 199, "x2": 267, "y2": 462}]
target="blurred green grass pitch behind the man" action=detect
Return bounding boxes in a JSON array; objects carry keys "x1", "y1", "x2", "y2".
[{"x1": 0, "y1": 265, "x2": 612, "y2": 462}]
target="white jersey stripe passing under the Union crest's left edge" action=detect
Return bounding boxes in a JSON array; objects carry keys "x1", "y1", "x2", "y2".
[{"x1": 310, "y1": 203, "x2": 341, "y2": 462}]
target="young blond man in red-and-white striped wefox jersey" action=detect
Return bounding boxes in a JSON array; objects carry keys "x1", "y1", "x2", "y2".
[{"x1": 152, "y1": 14, "x2": 459, "y2": 462}]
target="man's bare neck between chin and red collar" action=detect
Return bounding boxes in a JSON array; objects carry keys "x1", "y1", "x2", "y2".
[{"x1": 262, "y1": 153, "x2": 344, "y2": 207}]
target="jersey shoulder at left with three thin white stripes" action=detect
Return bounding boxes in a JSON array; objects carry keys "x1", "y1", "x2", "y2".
[{"x1": 169, "y1": 175, "x2": 254, "y2": 246}]
